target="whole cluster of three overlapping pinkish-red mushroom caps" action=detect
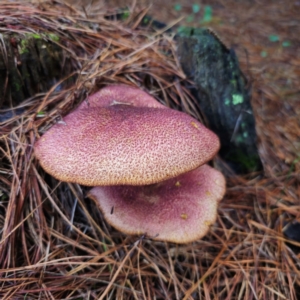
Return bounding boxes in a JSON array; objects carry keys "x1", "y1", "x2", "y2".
[{"x1": 34, "y1": 86, "x2": 225, "y2": 243}]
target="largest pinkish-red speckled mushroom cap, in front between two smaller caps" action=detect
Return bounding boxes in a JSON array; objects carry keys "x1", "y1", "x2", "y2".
[{"x1": 34, "y1": 105, "x2": 219, "y2": 186}]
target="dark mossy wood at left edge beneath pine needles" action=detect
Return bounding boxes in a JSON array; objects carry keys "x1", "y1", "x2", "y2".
[{"x1": 0, "y1": 33, "x2": 71, "y2": 108}]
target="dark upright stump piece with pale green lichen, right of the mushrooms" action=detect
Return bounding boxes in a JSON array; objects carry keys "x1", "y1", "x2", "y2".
[{"x1": 177, "y1": 28, "x2": 262, "y2": 173}]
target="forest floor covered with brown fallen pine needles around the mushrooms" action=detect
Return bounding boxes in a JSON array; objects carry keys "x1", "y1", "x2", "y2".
[{"x1": 0, "y1": 0, "x2": 300, "y2": 300}]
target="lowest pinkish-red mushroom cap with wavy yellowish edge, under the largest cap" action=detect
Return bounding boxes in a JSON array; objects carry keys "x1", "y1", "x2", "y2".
[{"x1": 88, "y1": 165, "x2": 225, "y2": 243}]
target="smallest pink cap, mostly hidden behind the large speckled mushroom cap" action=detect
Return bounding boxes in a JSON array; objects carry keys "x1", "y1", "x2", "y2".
[{"x1": 78, "y1": 84, "x2": 167, "y2": 109}]
